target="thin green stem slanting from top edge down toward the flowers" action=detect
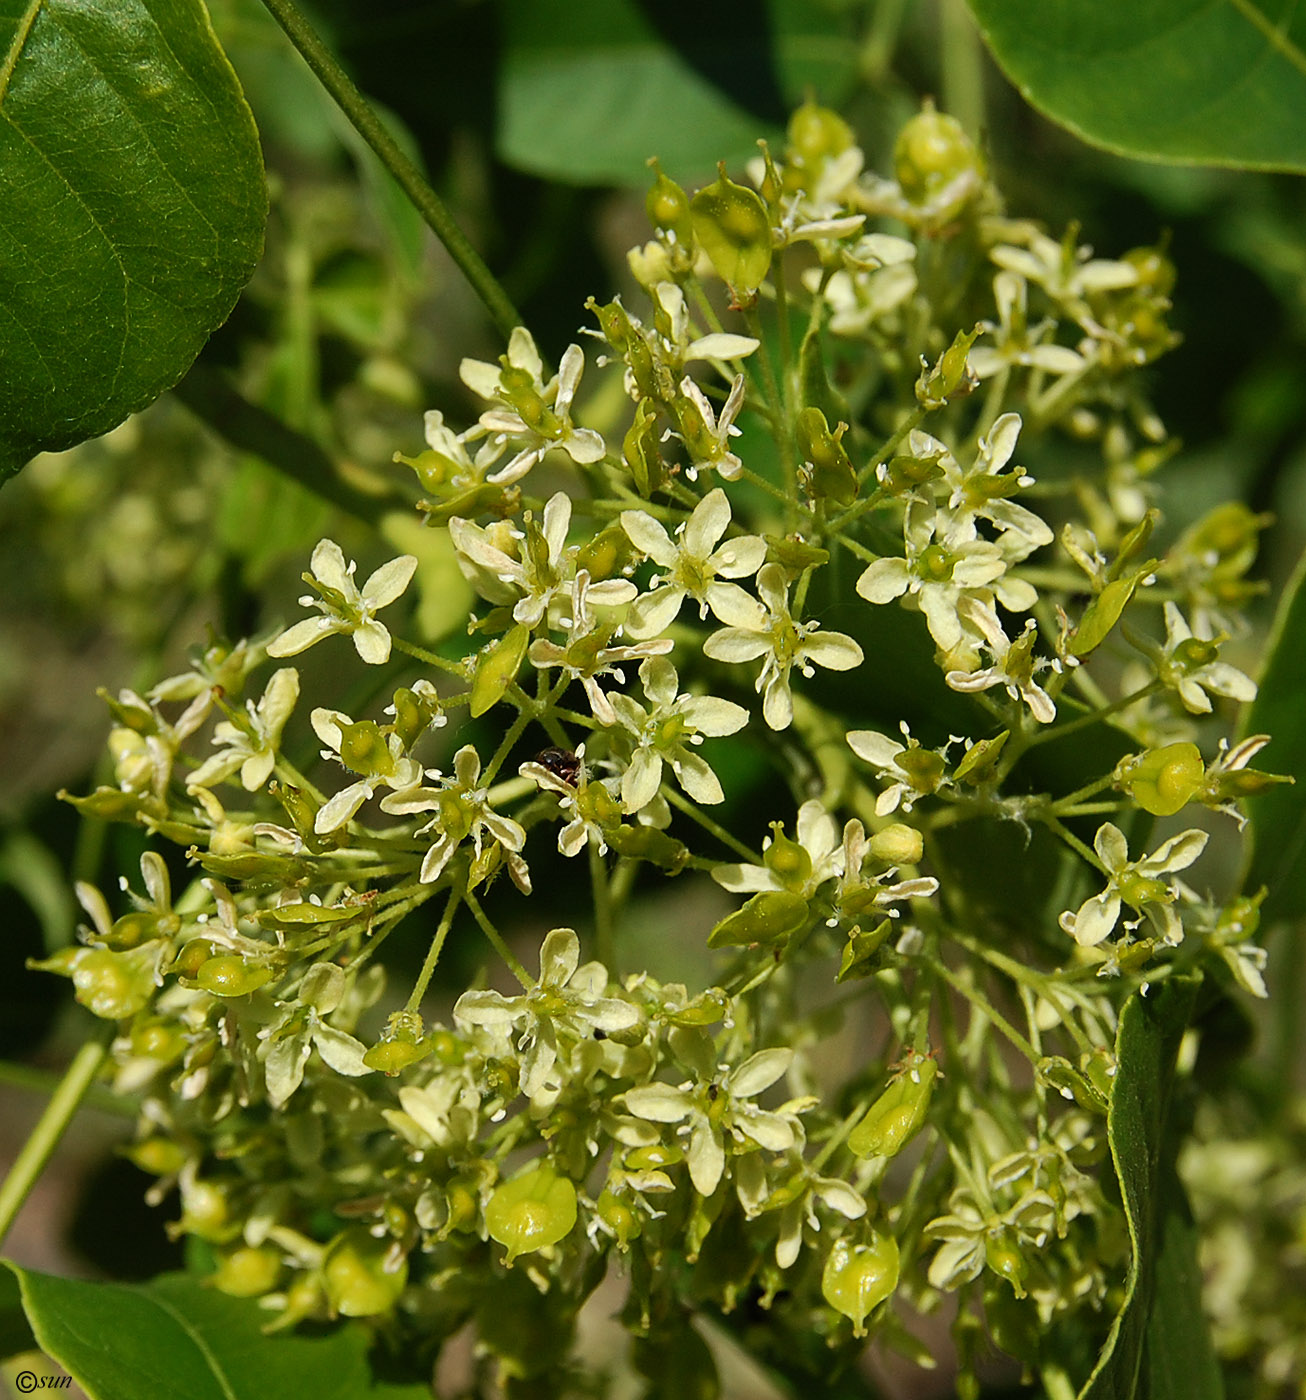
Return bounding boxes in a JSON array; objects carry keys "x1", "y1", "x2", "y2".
[{"x1": 254, "y1": 0, "x2": 522, "y2": 339}]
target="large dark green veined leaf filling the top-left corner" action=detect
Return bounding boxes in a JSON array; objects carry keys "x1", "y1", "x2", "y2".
[{"x1": 0, "y1": 0, "x2": 267, "y2": 480}]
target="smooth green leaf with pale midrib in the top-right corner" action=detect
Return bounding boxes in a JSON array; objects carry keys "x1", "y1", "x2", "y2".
[{"x1": 970, "y1": 0, "x2": 1306, "y2": 171}]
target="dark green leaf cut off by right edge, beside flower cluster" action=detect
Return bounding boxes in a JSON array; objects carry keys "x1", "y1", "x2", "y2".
[{"x1": 1242, "y1": 557, "x2": 1306, "y2": 924}]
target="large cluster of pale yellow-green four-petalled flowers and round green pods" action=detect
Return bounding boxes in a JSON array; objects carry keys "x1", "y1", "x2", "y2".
[{"x1": 45, "y1": 104, "x2": 1275, "y2": 1393}]
